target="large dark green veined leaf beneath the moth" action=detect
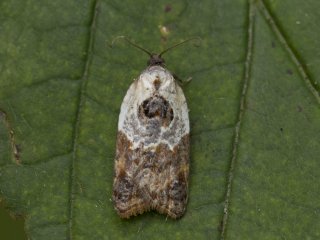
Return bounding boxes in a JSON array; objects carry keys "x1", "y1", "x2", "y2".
[{"x1": 0, "y1": 0, "x2": 320, "y2": 239}]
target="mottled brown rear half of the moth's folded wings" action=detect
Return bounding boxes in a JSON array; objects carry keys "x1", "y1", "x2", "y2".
[{"x1": 113, "y1": 131, "x2": 189, "y2": 218}]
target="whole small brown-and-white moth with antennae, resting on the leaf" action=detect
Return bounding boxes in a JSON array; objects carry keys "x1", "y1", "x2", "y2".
[{"x1": 113, "y1": 37, "x2": 198, "y2": 219}]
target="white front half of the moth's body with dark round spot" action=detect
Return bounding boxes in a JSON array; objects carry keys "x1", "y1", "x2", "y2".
[{"x1": 118, "y1": 66, "x2": 190, "y2": 150}]
